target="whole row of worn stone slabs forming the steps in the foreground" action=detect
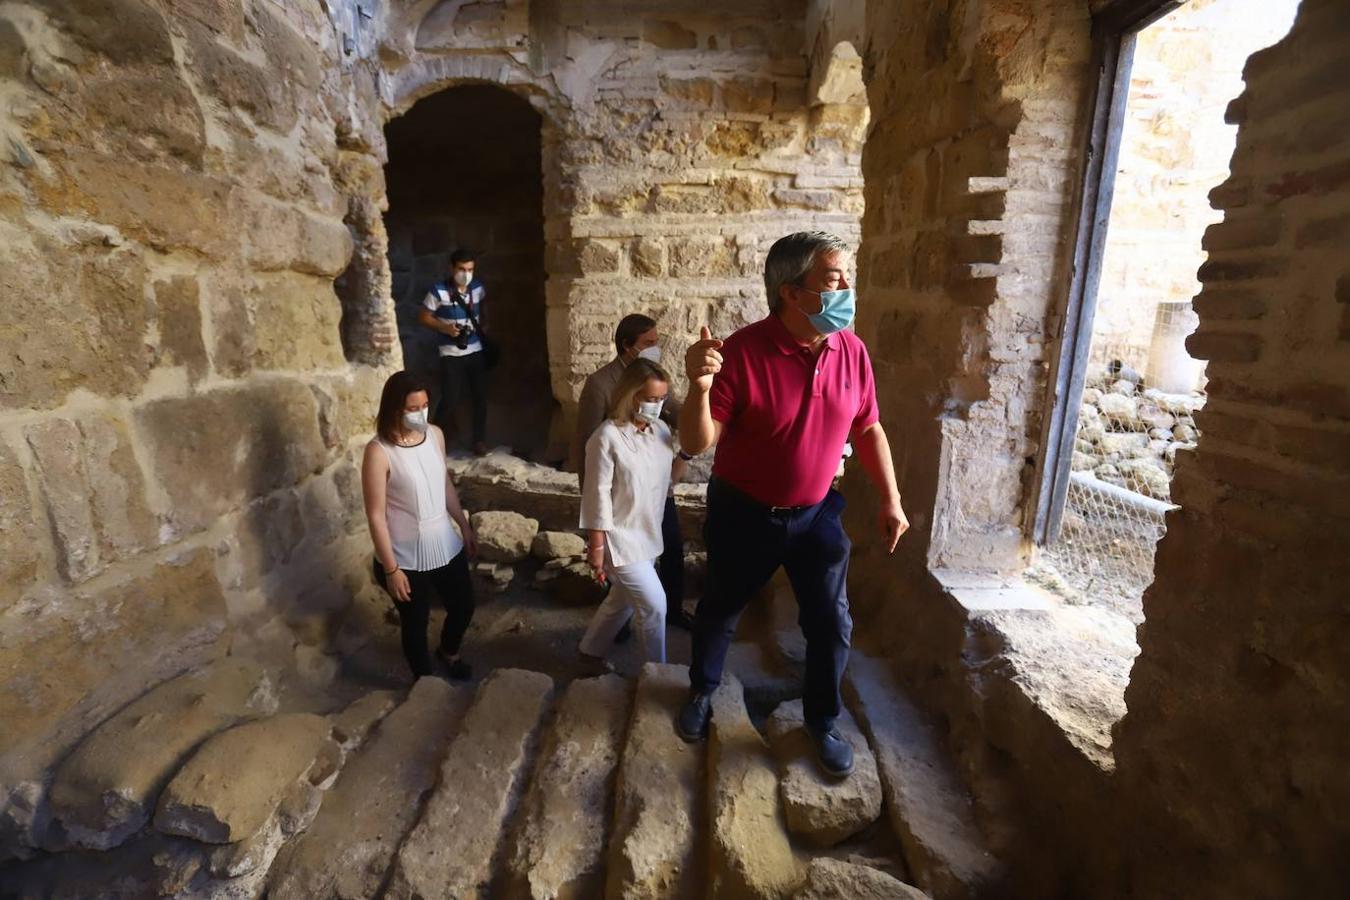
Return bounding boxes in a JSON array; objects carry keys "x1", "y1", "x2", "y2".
[{"x1": 0, "y1": 656, "x2": 999, "y2": 900}]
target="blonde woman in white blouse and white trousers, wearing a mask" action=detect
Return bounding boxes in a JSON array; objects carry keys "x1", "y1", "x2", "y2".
[{"x1": 581, "y1": 359, "x2": 675, "y2": 668}]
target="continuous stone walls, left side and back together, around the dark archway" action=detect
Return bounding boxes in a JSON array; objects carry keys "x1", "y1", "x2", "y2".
[{"x1": 0, "y1": 0, "x2": 865, "y2": 854}]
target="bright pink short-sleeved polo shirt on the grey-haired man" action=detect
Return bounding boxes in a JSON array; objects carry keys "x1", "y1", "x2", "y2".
[{"x1": 709, "y1": 314, "x2": 878, "y2": 506}]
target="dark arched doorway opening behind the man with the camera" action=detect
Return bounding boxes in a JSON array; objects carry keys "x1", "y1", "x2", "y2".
[{"x1": 385, "y1": 85, "x2": 558, "y2": 457}]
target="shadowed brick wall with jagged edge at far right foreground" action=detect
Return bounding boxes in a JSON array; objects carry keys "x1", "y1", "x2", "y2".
[{"x1": 1115, "y1": 0, "x2": 1350, "y2": 897}]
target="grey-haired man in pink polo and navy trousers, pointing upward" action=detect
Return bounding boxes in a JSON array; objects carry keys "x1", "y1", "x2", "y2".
[{"x1": 676, "y1": 232, "x2": 909, "y2": 777}]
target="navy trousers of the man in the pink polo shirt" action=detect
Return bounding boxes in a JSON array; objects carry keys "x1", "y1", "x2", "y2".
[{"x1": 689, "y1": 479, "x2": 853, "y2": 730}]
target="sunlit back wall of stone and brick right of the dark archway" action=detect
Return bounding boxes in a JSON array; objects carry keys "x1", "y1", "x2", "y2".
[{"x1": 378, "y1": 0, "x2": 867, "y2": 458}]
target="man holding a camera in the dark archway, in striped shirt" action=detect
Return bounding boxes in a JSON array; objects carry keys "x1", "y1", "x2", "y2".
[{"x1": 417, "y1": 248, "x2": 487, "y2": 456}]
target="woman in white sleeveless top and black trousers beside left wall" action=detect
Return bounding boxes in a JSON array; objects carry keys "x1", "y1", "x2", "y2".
[{"x1": 360, "y1": 372, "x2": 478, "y2": 679}]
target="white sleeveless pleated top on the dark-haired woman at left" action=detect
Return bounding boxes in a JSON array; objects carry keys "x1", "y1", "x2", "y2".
[{"x1": 371, "y1": 433, "x2": 464, "y2": 572}]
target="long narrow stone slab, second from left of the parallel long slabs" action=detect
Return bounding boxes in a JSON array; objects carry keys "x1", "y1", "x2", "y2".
[{"x1": 385, "y1": 669, "x2": 554, "y2": 900}]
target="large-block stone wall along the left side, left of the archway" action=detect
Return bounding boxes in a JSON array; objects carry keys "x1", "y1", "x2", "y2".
[{"x1": 0, "y1": 0, "x2": 397, "y2": 854}]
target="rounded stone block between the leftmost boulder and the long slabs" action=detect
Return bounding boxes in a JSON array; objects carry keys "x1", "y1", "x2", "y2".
[{"x1": 155, "y1": 712, "x2": 329, "y2": 843}]
